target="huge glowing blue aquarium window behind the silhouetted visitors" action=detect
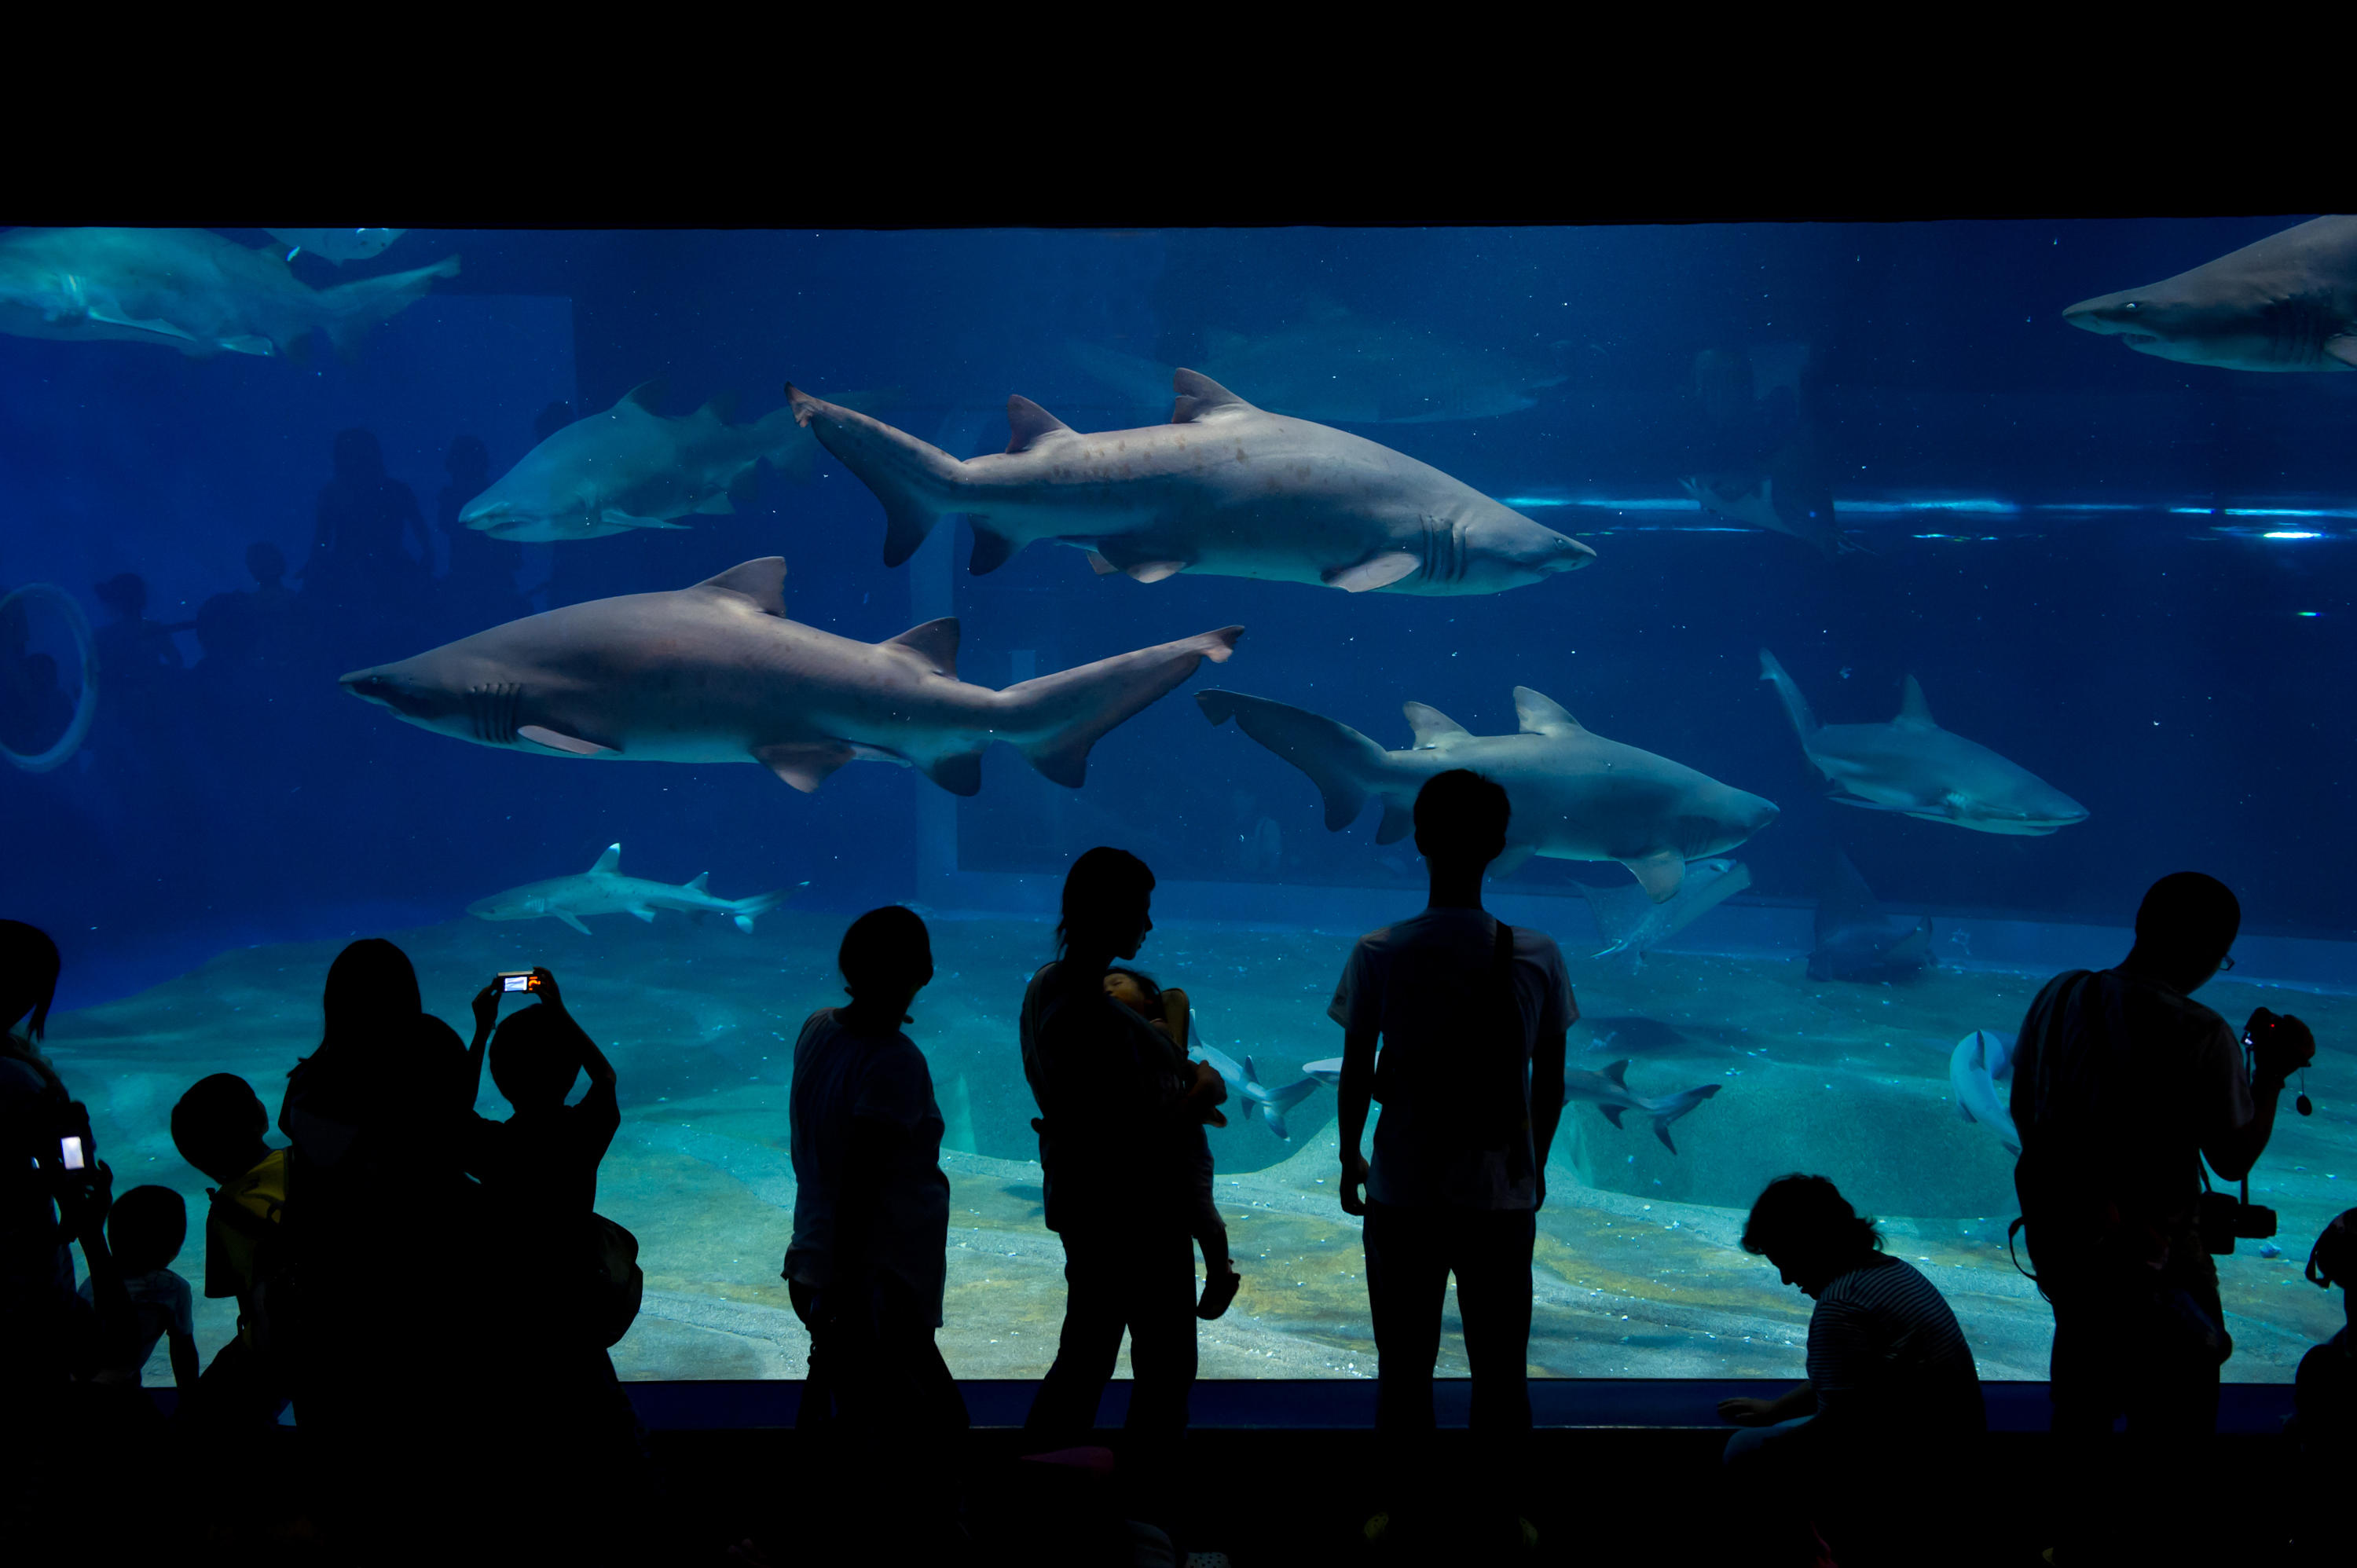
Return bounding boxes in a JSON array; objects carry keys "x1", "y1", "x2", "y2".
[{"x1": 0, "y1": 214, "x2": 2357, "y2": 1384}]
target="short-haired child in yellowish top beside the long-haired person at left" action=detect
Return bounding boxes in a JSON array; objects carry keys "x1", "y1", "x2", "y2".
[{"x1": 172, "y1": 1073, "x2": 290, "y2": 1422}]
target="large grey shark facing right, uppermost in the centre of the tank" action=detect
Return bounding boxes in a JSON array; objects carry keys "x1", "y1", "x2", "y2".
[{"x1": 785, "y1": 370, "x2": 1596, "y2": 594}]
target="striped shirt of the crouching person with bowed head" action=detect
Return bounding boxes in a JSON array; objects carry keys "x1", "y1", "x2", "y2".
[{"x1": 1808, "y1": 1252, "x2": 1985, "y2": 1429}]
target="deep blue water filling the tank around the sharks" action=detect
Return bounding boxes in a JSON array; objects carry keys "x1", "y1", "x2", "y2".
[{"x1": 0, "y1": 219, "x2": 2357, "y2": 1377}]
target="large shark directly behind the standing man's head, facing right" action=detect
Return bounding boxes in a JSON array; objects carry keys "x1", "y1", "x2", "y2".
[{"x1": 1195, "y1": 686, "x2": 1775, "y2": 903}]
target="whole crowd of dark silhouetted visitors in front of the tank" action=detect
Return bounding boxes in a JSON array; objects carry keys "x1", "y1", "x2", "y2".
[{"x1": 0, "y1": 764, "x2": 2357, "y2": 1568}]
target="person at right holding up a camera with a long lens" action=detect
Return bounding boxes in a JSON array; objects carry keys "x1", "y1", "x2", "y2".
[{"x1": 2013, "y1": 870, "x2": 2317, "y2": 1438}]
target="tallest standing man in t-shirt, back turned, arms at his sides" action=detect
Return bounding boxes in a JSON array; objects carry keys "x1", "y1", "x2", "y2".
[{"x1": 1327, "y1": 768, "x2": 1579, "y2": 1537}]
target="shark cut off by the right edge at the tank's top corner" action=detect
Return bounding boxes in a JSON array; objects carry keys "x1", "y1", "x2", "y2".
[{"x1": 2062, "y1": 217, "x2": 2357, "y2": 370}]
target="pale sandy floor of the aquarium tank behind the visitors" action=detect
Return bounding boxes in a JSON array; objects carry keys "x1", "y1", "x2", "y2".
[{"x1": 49, "y1": 903, "x2": 2357, "y2": 1384}]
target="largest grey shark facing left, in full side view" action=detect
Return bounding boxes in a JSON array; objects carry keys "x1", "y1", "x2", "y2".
[{"x1": 344, "y1": 556, "x2": 1244, "y2": 795}]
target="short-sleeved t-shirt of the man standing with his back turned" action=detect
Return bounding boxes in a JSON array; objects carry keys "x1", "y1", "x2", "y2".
[{"x1": 1327, "y1": 908, "x2": 1579, "y2": 1210}]
